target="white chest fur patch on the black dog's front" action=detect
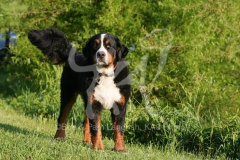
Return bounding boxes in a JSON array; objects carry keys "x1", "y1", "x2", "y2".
[{"x1": 93, "y1": 76, "x2": 121, "y2": 109}]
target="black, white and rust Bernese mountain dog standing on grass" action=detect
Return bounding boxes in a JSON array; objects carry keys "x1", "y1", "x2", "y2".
[{"x1": 28, "y1": 28, "x2": 131, "y2": 151}]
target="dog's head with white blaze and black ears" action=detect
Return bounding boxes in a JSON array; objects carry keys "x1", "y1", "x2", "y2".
[{"x1": 83, "y1": 33, "x2": 128, "y2": 73}]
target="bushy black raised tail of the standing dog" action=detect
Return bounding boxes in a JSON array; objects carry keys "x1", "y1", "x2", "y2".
[{"x1": 28, "y1": 28, "x2": 72, "y2": 64}]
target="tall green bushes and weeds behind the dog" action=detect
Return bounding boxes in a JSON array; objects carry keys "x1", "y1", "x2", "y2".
[{"x1": 0, "y1": 0, "x2": 240, "y2": 158}]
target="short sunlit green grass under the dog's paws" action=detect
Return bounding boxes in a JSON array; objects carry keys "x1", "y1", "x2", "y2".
[{"x1": 0, "y1": 101, "x2": 206, "y2": 160}]
